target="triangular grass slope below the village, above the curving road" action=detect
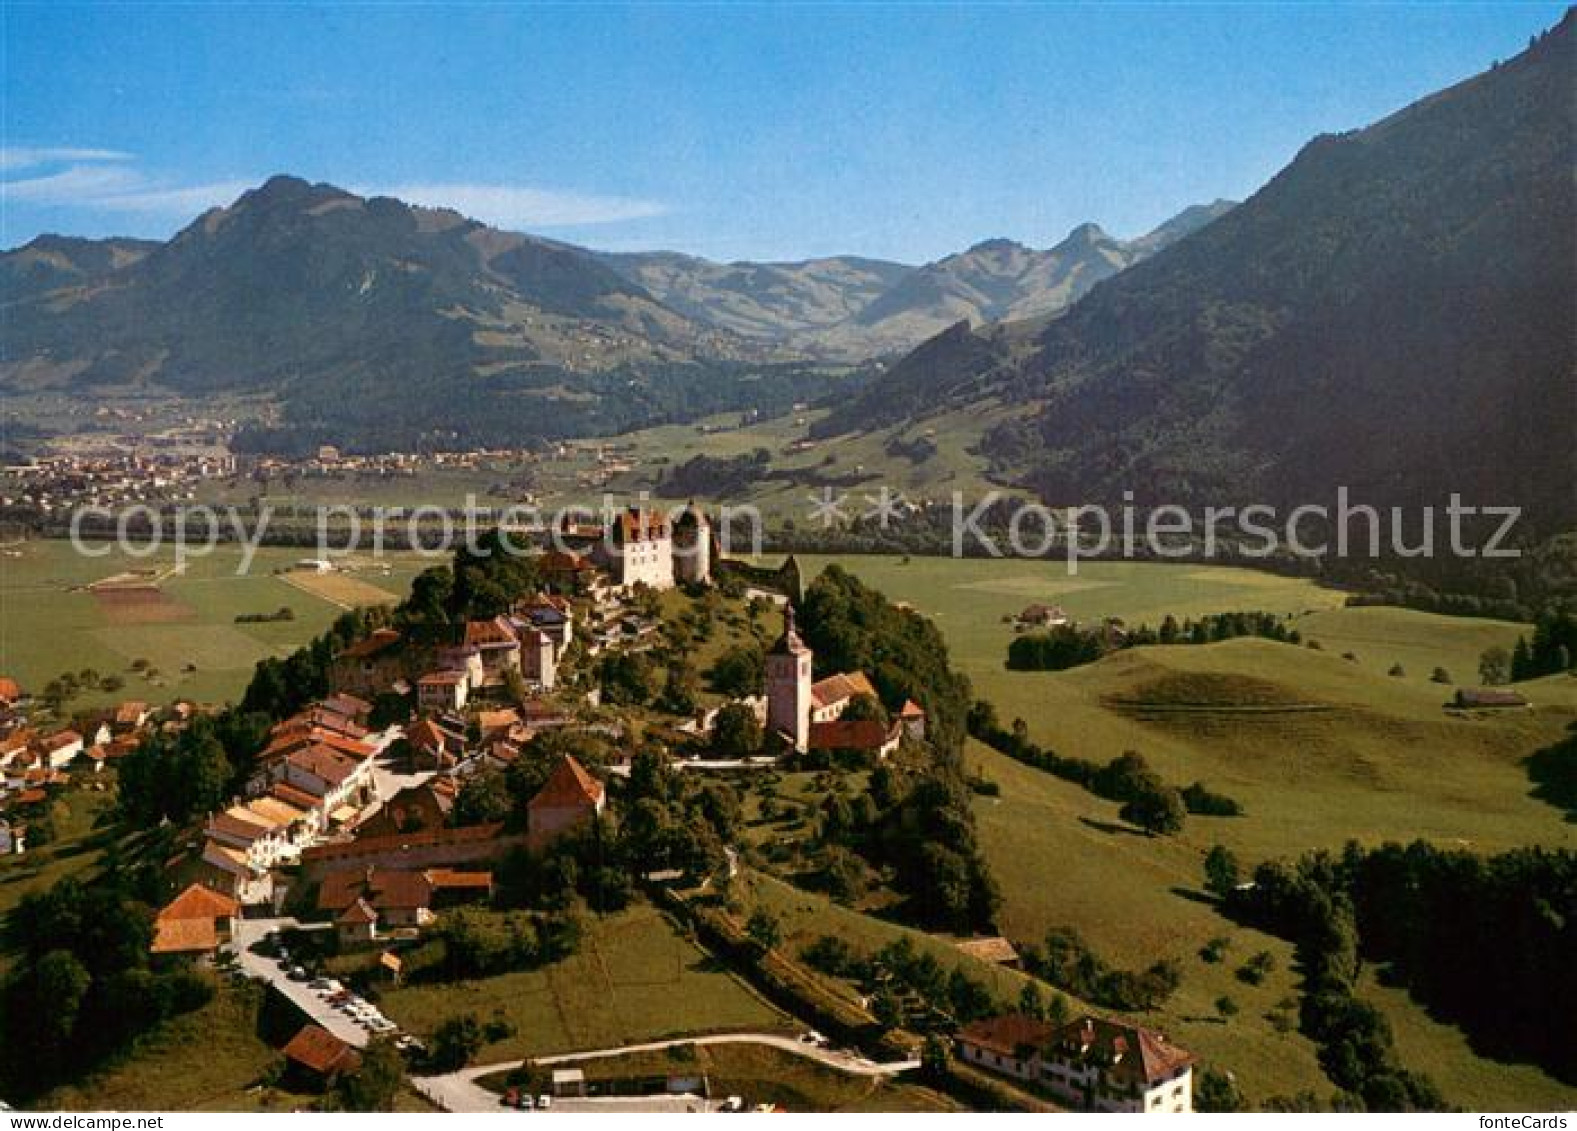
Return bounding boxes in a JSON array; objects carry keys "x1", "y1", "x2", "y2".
[{"x1": 382, "y1": 904, "x2": 792, "y2": 1063}]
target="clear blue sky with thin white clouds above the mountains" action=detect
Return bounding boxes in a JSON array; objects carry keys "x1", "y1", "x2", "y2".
[{"x1": 0, "y1": 0, "x2": 1564, "y2": 263}]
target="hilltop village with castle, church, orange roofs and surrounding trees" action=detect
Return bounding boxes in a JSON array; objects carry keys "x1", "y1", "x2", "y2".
[{"x1": 0, "y1": 508, "x2": 1194, "y2": 1112}]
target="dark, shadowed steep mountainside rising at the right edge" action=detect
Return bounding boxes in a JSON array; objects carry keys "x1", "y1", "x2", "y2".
[{"x1": 818, "y1": 13, "x2": 1577, "y2": 526}]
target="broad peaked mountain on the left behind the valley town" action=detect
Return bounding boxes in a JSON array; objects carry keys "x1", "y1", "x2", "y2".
[{"x1": 0, "y1": 177, "x2": 851, "y2": 448}]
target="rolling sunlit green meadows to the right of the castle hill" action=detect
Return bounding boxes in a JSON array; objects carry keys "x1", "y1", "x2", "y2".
[{"x1": 775, "y1": 557, "x2": 1577, "y2": 1107}]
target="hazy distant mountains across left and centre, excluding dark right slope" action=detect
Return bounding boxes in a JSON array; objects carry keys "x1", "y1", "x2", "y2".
[{"x1": 0, "y1": 177, "x2": 1230, "y2": 451}]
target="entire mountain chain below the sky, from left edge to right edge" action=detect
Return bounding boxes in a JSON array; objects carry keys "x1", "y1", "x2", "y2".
[{"x1": 0, "y1": 13, "x2": 1577, "y2": 522}]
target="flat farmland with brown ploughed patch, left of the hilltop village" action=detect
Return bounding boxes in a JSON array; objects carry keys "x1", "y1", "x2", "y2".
[{"x1": 0, "y1": 541, "x2": 426, "y2": 708}]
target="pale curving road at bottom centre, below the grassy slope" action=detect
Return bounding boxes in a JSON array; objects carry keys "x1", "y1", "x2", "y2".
[{"x1": 413, "y1": 1033, "x2": 919, "y2": 1112}]
